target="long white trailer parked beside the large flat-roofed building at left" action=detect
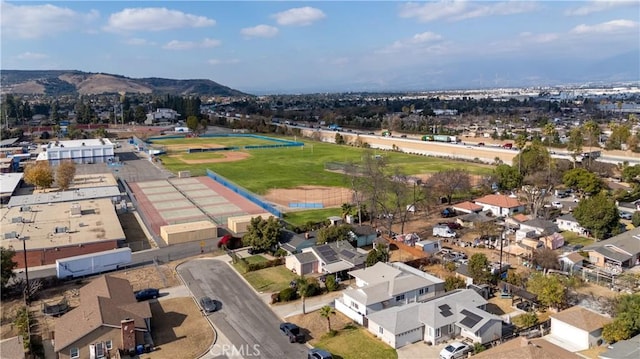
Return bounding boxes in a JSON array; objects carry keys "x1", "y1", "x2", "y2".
[{"x1": 56, "y1": 248, "x2": 131, "y2": 279}]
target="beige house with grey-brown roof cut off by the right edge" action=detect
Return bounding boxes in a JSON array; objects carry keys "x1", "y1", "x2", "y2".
[{"x1": 583, "y1": 227, "x2": 640, "y2": 273}]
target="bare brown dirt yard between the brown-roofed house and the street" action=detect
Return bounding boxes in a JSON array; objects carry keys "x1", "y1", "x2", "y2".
[{"x1": 140, "y1": 298, "x2": 214, "y2": 359}]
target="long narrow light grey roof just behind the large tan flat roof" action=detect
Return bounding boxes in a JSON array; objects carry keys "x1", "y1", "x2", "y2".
[{"x1": 7, "y1": 186, "x2": 121, "y2": 207}]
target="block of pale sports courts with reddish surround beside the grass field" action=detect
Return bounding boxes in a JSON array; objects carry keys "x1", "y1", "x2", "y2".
[{"x1": 129, "y1": 176, "x2": 265, "y2": 236}]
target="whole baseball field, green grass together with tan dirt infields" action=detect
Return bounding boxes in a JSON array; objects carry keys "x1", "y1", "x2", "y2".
[{"x1": 154, "y1": 136, "x2": 493, "y2": 206}]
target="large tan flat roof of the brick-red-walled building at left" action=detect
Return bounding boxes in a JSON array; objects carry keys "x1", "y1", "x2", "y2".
[{"x1": 0, "y1": 198, "x2": 125, "y2": 250}]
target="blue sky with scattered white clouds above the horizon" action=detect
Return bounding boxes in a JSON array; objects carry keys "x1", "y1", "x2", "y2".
[{"x1": 0, "y1": 0, "x2": 640, "y2": 93}]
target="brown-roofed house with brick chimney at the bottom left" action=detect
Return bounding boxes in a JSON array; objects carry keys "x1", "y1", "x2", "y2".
[{"x1": 54, "y1": 275, "x2": 153, "y2": 359}]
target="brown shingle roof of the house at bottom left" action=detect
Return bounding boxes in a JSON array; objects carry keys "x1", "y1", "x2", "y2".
[{"x1": 55, "y1": 275, "x2": 151, "y2": 352}]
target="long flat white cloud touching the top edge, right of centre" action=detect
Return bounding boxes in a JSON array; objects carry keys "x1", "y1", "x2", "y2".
[{"x1": 399, "y1": 1, "x2": 538, "y2": 22}]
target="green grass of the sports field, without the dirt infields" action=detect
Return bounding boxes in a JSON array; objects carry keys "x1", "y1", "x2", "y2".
[{"x1": 156, "y1": 137, "x2": 492, "y2": 194}]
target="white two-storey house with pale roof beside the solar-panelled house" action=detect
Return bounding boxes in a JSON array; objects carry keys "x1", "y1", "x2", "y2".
[{"x1": 335, "y1": 262, "x2": 444, "y2": 325}]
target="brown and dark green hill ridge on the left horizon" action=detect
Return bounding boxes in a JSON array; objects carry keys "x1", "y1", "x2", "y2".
[{"x1": 0, "y1": 70, "x2": 248, "y2": 97}]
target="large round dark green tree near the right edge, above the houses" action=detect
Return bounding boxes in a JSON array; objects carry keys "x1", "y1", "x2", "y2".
[{"x1": 573, "y1": 193, "x2": 620, "y2": 240}]
